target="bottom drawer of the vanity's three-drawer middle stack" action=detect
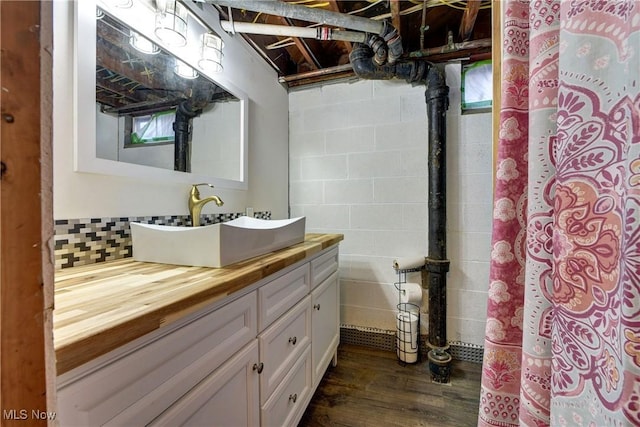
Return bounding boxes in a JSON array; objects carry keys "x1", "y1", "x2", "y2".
[{"x1": 260, "y1": 347, "x2": 311, "y2": 427}]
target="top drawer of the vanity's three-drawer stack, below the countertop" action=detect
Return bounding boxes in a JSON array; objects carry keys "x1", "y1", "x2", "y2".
[{"x1": 258, "y1": 264, "x2": 311, "y2": 331}]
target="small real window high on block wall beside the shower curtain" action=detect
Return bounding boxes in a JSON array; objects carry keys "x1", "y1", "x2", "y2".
[{"x1": 460, "y1": 59, "x2": 493, "y2": 113}]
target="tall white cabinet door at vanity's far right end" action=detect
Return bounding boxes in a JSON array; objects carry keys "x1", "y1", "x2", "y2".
[{"x1": 311, "y1": 271, "x2": 340, "y2": 388}]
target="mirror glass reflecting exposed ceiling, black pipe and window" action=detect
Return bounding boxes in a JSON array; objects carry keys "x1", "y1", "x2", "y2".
[{"x1": 95, "y1": 6, "x2": 243, "y2": 180}]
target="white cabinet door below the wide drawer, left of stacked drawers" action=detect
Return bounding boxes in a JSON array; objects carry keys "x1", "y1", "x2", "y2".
[{"x1": 149, "y1": 340, "x2": 260, "y2": 427}]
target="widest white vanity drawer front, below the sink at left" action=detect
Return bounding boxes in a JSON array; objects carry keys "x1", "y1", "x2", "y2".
[{"x1": 58, "y1": 292, "x2": 257, "y2": 426}]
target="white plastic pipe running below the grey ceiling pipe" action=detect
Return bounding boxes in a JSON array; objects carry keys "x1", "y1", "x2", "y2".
[{"x1": 220, "y1": 21, "x2": 366, "y2": 43}]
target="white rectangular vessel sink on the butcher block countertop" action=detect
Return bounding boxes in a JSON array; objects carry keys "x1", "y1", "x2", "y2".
[{"x1": 130, "y1": 216, "x2": 305, "y2": 267}]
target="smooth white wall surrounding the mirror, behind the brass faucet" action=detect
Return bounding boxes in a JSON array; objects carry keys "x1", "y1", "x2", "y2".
[{"x1": 53, "y1": 1, "x2": 288, "y2": 219}]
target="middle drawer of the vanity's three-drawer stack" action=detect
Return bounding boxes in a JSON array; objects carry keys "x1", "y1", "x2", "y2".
[{"x1": 258, "y1": 296, "x2": 311, "y2": 403}]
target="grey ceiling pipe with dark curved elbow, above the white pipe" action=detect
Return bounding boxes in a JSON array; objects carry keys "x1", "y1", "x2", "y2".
[{"x1": 207, "y1": 0, "x2": 403, "y2": 65}]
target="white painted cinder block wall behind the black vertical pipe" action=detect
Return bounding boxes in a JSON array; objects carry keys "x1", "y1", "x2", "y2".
[{"x1": 289, "y1": 65, "x2": 492, "y2": 345}]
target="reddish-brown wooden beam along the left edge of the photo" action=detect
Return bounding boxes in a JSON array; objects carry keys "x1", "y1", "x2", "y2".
[{"x1": 0, "y1": 1, "x2": 53, "y2": 426}]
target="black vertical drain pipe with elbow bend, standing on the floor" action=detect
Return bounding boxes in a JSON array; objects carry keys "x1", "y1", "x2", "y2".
[{"x1": 349, "y1": 44, "x2": 451, "y2": 383}]
